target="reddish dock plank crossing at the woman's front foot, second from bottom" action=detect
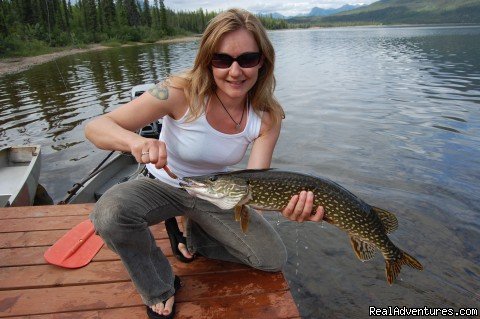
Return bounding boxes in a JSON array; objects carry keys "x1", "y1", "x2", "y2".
[{"x1": 0, "y1": 270, "x2": 287, "y2": 316}]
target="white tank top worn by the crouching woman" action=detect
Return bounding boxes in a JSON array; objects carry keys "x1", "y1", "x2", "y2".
[{"x1": 147, "y1": 105, "x2": 262, "y2": 187}]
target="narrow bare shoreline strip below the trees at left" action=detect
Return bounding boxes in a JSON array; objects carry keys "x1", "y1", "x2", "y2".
[{"x1": 0, "y1": 36, "x2": 200, "y2": 76}]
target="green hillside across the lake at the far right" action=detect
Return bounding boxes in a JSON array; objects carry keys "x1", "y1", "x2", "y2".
[{"x1": 308, "y1": 0, "x2": 480, "y2": 24}]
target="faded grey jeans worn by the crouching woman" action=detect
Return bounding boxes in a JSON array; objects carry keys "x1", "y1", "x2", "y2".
[{"x1": 90, "y1": 177, "x2": 287, "y2": 306}]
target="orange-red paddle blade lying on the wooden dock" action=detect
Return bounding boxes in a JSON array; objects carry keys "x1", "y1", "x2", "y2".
[{"x1": 43, "y1": 220, "x2": 103, "y2": 268}]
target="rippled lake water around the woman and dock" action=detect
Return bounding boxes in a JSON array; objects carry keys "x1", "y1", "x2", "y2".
[{"x1": 0, "y1": 26, "x2": 480, "y2": 318}]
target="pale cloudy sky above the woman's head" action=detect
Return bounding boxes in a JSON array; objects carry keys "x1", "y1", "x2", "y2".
[{"x1": 164, "y1": 0, "x2": 378, "y2": 16}]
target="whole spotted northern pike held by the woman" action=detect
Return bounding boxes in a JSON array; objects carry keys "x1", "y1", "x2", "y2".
[{"x1": 180, "y1": 169, "x2": 423, "y2": 284}]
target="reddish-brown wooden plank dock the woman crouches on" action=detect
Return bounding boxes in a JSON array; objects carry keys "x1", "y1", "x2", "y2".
[{"x1": 0, "y1": 204, "x2": 300, "y2": 319}]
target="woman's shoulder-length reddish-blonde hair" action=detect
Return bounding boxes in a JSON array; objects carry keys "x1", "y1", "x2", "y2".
[{"x1": 167, "y1": 9, "x2": 284, "y2": 127}]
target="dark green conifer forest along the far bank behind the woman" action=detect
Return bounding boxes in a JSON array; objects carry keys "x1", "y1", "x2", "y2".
[{"x1": 0, "y1": 0, "x2": 287, "y2": 57}]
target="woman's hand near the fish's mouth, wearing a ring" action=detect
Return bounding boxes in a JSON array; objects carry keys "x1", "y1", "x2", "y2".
[{"x1": 131, "y1": 138, "x2": 167, "y2": 169}]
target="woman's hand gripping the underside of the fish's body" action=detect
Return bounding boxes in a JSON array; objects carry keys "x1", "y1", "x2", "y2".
[{"x1": 282, "y1": 191, "x2": 324, "y2": 223}]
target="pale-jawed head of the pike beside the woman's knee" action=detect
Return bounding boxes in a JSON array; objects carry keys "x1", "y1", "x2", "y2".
[{"x1": 180, "y1": 173, "x2": 249, "y2": 209}]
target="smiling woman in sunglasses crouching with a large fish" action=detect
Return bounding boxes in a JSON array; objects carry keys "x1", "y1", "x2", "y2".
[{"x1": 85, "y1": 9, "x2": 323, "y2": 318}]
